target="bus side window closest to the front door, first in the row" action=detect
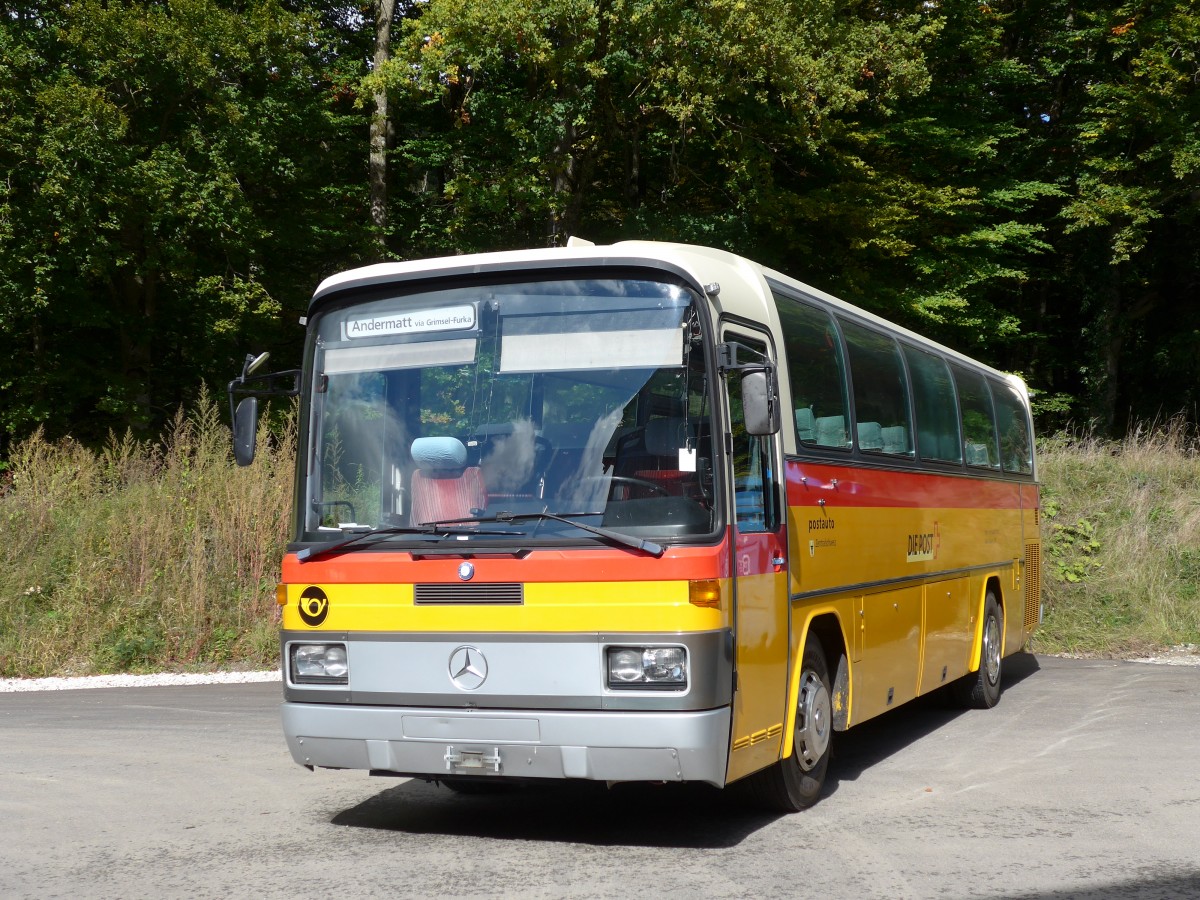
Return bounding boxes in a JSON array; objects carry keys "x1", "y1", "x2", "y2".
[{"x1": 775, "y1": 294, "x2": 850, "y2": 449}]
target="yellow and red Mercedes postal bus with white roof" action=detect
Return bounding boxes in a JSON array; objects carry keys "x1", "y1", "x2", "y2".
[{"x1": 230, "y1": 240, "x2": 1040, "y2": 810}]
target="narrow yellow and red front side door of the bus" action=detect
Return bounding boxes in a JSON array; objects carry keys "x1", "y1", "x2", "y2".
[{"x1": 722, "y1": 328, "x2": 791, "y2": 780}]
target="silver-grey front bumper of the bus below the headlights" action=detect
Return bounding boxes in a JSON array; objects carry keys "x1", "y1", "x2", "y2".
[{"x1": 282, "y1": 703, "x2": 730, "y2": 787}]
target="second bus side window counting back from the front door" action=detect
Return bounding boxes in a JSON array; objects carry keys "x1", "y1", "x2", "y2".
[{"x1": 841, "y1": 320, "x2": 912, "y2": 456}]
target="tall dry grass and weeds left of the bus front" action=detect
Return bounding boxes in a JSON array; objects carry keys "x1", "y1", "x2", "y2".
[{"x1": 0, "y1": 392, "x2": 295, "y2": 676}]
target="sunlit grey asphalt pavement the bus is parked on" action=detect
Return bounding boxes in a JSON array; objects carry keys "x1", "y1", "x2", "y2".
[{"x1": 0, "y1": 655, "x2": 1200, "y2": 900}]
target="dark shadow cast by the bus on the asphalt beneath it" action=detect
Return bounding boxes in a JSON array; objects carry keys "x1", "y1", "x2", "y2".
[{"x1": 331, "y1": 654, "x2": 1038, "y2": 850}]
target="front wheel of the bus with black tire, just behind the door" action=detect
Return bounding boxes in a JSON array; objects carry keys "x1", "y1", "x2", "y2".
[{"x1": 745, "y1": 634, "x2": 833, "y2": 812}]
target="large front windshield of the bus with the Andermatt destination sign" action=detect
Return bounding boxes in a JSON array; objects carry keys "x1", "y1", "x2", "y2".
[{"x1": 299, "y1": 278, "x2": 715, "y2": 547}]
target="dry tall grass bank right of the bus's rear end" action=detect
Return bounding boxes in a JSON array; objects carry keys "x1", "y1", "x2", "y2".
[{"x1": 1033, "y1": 420, "x2": 1200, "y2": 655}]
